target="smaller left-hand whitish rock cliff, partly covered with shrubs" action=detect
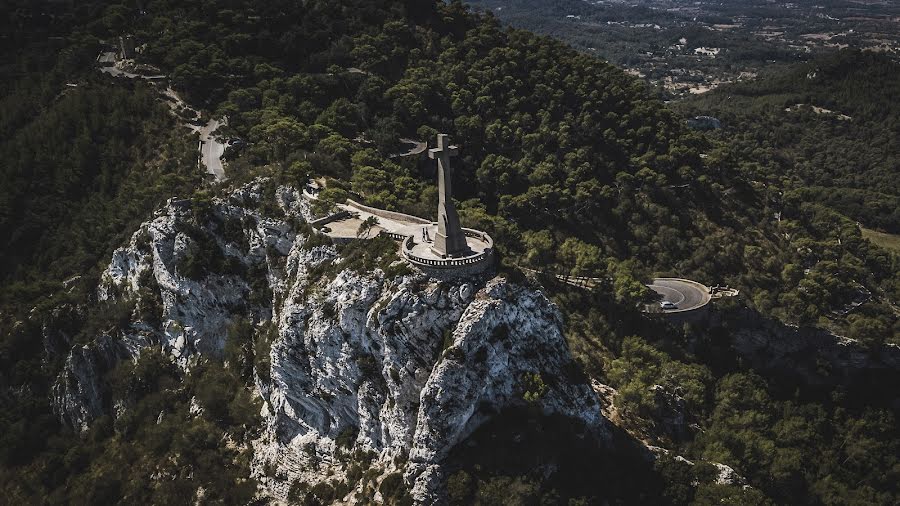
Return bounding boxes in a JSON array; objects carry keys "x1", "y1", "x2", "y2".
[{"x1": 51, "y1": 183, "x2": 302, "y2": 430}]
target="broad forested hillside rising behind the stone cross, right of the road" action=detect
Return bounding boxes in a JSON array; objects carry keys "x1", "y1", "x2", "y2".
[{"x1": 109, "y1": 2, "x2": 897, "y2": 342}]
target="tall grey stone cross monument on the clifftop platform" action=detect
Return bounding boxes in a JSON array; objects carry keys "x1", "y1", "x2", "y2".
[{"x1": 428, "y1": 134, "x2": 469, "y2": 258}]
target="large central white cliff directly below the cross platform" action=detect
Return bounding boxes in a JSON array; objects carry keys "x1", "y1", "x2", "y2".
[{"x1": 256, "y1": 241, "x2": 606, "y2": 503}]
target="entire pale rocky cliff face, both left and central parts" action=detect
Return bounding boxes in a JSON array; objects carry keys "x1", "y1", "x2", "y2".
[{"x1": 54, "y1": 185, "x2": 608, "y2": 503}]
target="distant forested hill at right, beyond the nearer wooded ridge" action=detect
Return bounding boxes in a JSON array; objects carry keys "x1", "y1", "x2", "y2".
[{"x1": 684, "y1": 51, "x2": 900, "y2": 233}]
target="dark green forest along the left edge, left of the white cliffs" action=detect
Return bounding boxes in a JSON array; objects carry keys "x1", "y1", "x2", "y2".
[{"x1": 0, "y1": 4, "x2": 214, "y2": 504}]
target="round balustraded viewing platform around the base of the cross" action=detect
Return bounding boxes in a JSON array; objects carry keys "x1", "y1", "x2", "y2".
[{"x1": 400, "y1": 223, "x2": 494, "y2": 273}]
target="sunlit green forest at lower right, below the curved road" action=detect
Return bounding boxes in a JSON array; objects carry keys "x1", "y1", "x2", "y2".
[{"x1": 544, "y1": 278, "x2": 900, "y2": 504}]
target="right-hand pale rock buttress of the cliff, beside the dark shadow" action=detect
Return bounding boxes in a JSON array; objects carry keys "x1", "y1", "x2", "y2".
[{"x1": 407, "y1": 281, "x2": 607, "y2": 502}]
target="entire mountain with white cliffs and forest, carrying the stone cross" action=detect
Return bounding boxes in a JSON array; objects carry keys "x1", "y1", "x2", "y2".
[{"x1": 0, "y1": 0, "x2": 900, "y2": 504}]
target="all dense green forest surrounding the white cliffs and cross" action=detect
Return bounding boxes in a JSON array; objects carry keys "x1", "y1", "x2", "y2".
[{"x1": 0, "y1": 0, "x2": 900, "y2": 504}]
